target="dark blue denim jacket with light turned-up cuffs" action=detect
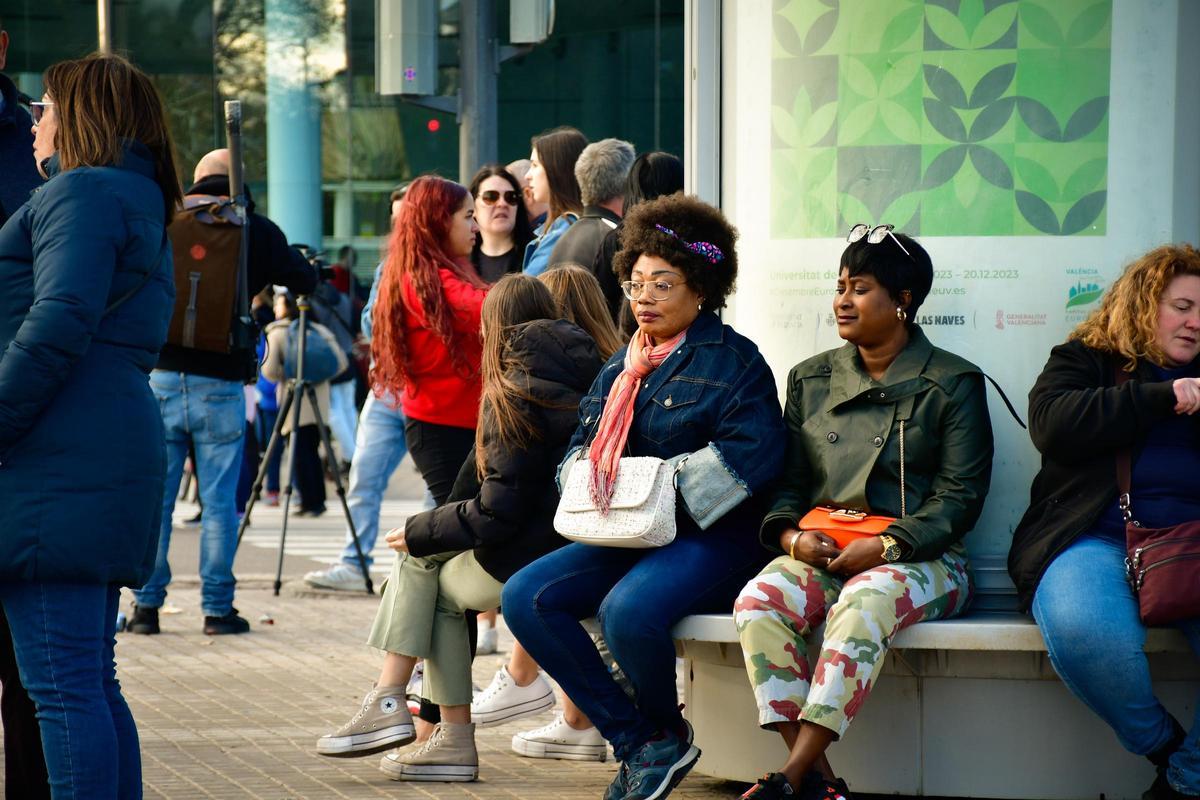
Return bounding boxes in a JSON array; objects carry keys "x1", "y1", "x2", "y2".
[{"x1": 558, "y1": 312, "x2": 786, "y2": 530}]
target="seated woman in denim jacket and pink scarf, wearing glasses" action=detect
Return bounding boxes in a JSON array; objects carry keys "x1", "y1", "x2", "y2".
[{"x1": 503, "y1": 194, "x2": 784, "y2": 800}]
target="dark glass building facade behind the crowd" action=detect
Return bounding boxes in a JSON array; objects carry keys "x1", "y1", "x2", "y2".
[{"x1": 0, "y1": 0, "x2": 684, "y2": 276}]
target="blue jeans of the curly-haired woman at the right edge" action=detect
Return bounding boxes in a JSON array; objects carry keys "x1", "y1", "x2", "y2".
[{"x1": 1033, "y1": 534, "x2": 1200, "y2": 795}]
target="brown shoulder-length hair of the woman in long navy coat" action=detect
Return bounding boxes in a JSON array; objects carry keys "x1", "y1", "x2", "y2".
[{"x1": 42, "y1": 53, "x2": 184, "y2": 224}]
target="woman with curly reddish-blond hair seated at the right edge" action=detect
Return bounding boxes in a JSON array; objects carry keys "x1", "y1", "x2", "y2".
[{"x1": 1008, "y1": 245, "x2": 1200, "y2": 800}]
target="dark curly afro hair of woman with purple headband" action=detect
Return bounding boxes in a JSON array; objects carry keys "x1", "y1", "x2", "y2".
[{"x1": 612, "y1": 192, "x2": 738, "y2": 311}]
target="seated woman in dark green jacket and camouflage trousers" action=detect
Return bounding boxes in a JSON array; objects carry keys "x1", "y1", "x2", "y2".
[{"x1": 733, "y1": 224, "x2": 992, "y2": 800}]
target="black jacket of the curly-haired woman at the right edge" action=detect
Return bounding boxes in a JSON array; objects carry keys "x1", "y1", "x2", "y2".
[{"x1": 1008, "y1": 342, "x2": 1185, "y2": 610}]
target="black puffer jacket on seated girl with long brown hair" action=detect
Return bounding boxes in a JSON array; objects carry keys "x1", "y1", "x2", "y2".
[{"x1": 404, "y1": 319, "x2": 602, "y2": 583}]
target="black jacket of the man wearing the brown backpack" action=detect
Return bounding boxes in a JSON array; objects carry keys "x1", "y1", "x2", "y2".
[{"x1": 156, "y1": 175, "x2": 317, "y2": 380}]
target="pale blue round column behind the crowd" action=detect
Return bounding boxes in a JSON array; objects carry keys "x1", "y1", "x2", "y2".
[{"x1": 266, "y1": 0, "x2": 322, "y2": 247}]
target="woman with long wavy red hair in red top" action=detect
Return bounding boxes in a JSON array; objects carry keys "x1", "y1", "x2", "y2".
[{"x1": 371, "y1": 175, "x2": 487, "y2": 505}]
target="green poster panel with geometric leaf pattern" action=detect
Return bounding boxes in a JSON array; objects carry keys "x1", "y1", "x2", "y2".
[{"x1": 772, "y1": 0, "x2": 1112, "y2": 239}]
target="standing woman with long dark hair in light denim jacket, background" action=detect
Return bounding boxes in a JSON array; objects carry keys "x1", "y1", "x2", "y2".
[{"x1": 524, "y1": 126, "x2": 588, "y2": 276}]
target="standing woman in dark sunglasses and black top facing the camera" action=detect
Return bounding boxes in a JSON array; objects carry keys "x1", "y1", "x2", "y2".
[{"x1": 470, "y1": 164, "x2": 533, "y2": 283}]
